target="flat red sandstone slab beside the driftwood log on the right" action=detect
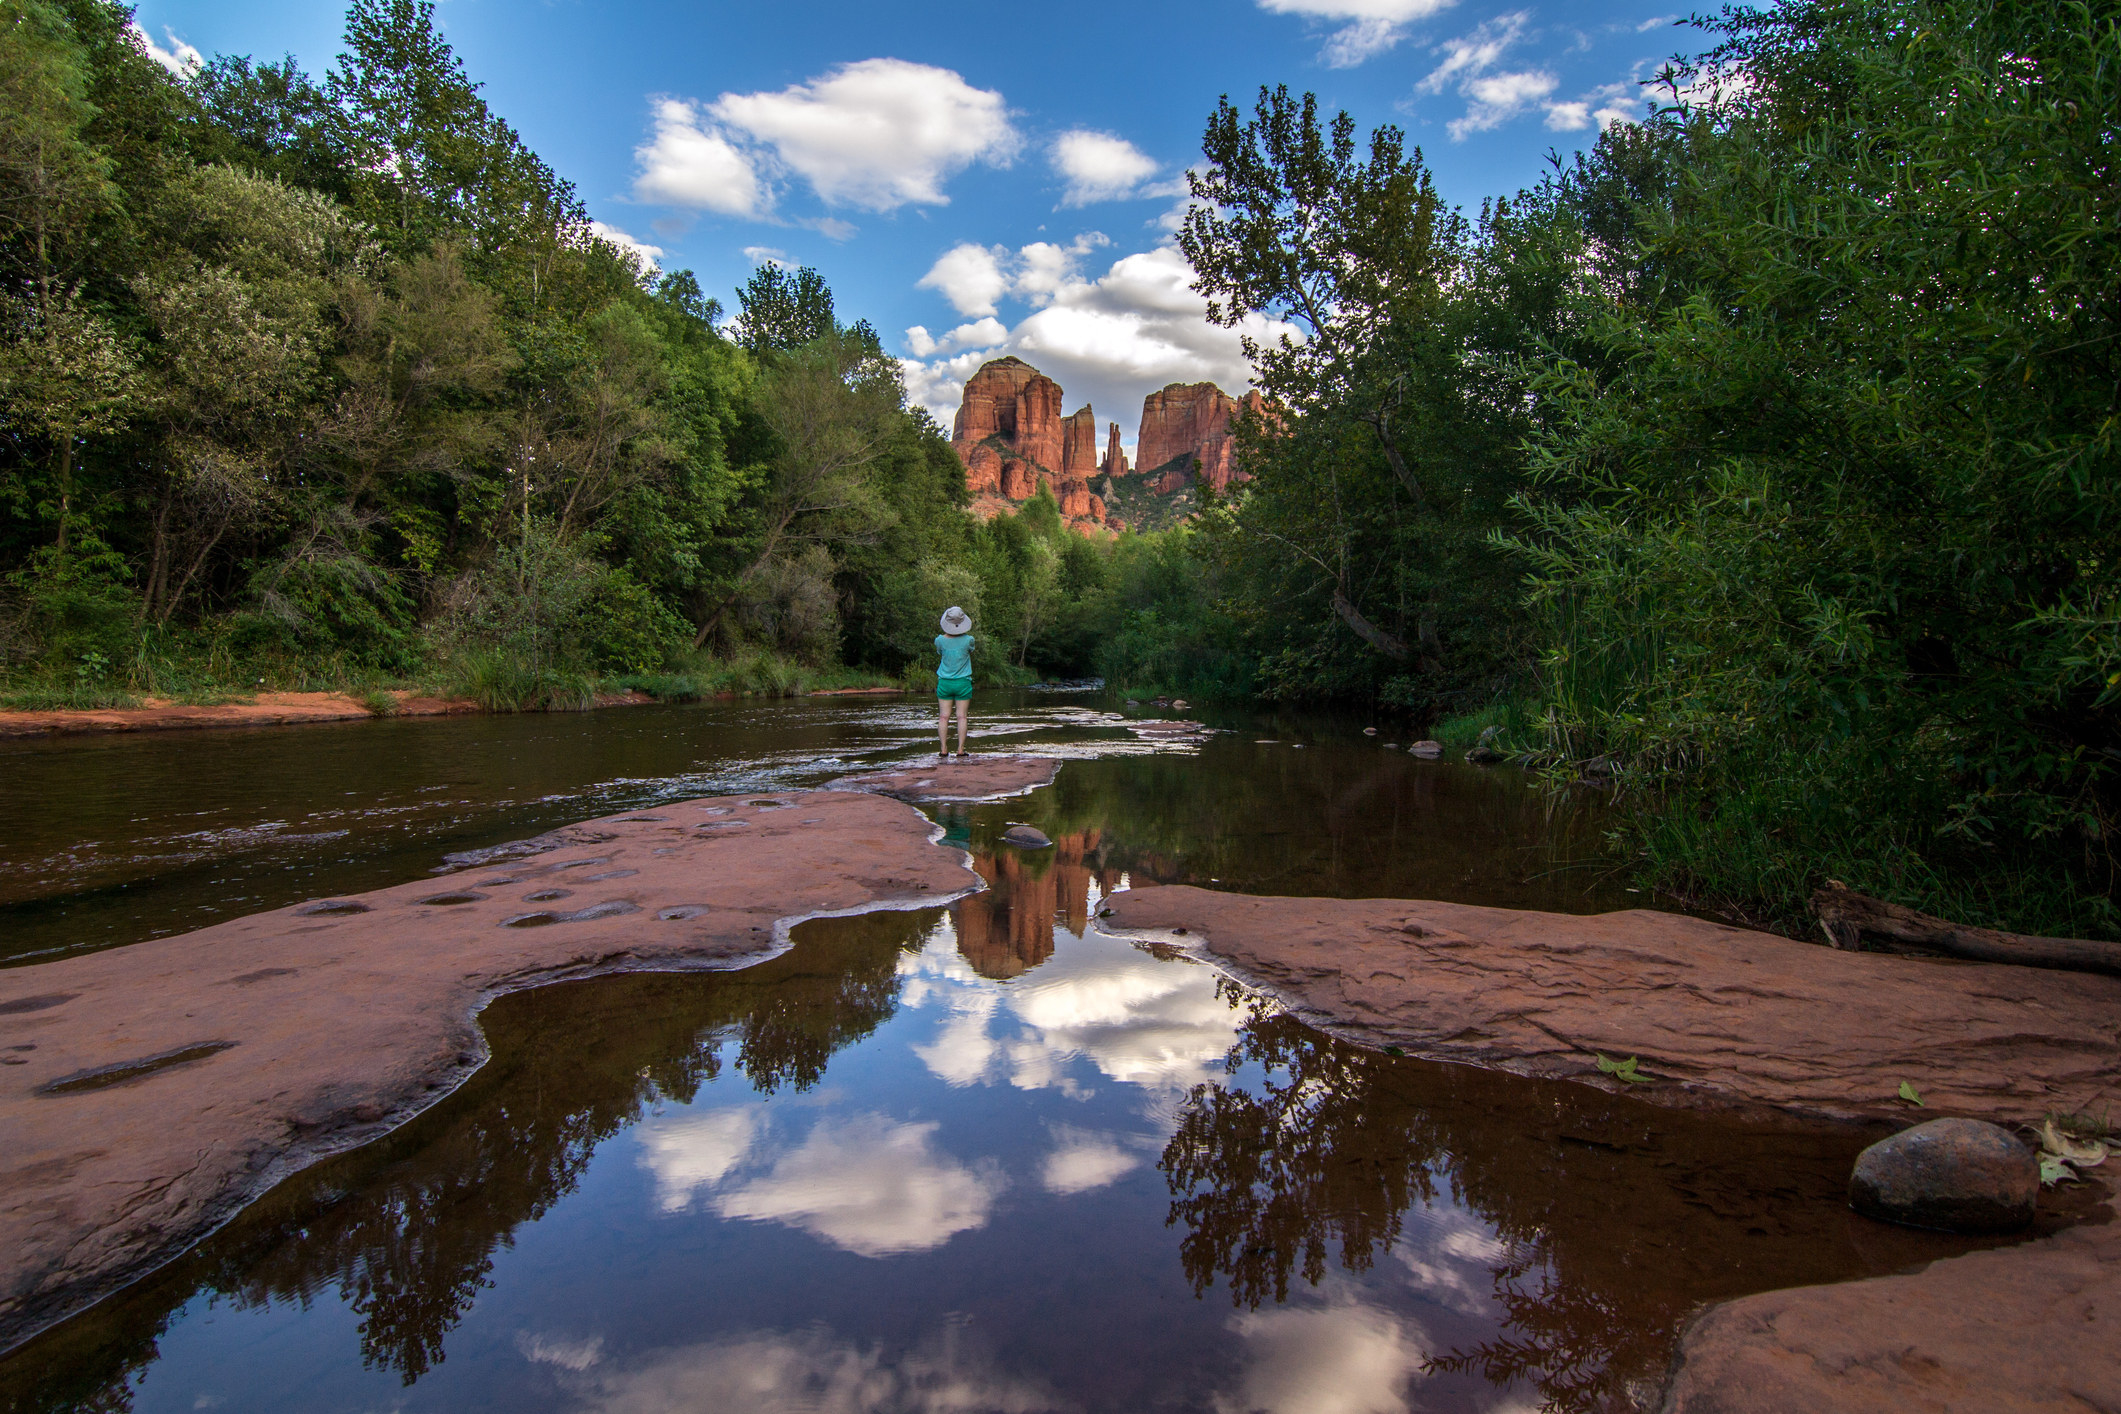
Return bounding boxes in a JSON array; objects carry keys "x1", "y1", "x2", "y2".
[{"x1": 1109, "y1": 886, "x2": 2121, "y2": 1124}]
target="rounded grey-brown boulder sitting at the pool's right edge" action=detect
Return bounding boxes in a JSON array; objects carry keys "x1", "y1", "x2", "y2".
[{"x1": 1850, "y1": 1119, "x2": 2040, "y2": 1232}]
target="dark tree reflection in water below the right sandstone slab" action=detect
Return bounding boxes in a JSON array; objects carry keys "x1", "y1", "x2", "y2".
[{"x1": 1160, "y1": 1013, "x2": 1966, "y2": 1412}]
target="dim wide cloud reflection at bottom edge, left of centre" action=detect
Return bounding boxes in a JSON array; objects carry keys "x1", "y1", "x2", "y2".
[{"x1": 559, "y1": 1327, "x2": 1067, "y2": 1414}]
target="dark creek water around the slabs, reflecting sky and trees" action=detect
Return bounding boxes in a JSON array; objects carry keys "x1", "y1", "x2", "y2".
[{"x1": 0, "y1": 700, "x2": 2019, "y2": 1414}]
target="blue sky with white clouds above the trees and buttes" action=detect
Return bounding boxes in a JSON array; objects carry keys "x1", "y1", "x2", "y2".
[{"x1": 138, "y1": 0, "x2": 1699, "y2": 443}]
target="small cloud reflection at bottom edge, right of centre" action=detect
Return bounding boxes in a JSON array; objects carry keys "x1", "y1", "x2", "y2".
[{"x1": 1215, "y1": 1300, "x2": 1427, "y2": 1414}]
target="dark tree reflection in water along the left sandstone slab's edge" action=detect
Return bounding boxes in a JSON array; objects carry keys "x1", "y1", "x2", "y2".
[{"x1": 0, "y1": 914, "x2": 935, "y2": 1414}]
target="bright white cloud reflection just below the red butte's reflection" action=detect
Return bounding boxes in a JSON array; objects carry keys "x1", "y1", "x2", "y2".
[{"x1": 899, "y1": 924, "x2": 1243, "y2": 1111}]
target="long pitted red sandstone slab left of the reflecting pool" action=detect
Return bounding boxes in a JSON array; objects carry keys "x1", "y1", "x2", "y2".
[{"x1": 0, "y1": 791, "x2": 978, "y2": 1348}]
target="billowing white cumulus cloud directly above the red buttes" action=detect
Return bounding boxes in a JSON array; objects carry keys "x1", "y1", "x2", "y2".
[{"x1": 901, "y1": 235, "x2": 1285, "y2": 447}]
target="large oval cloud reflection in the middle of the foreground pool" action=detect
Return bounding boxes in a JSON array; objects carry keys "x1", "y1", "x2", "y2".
[{"x1": 713, "y1": 1115, "x2": 1001, "y2": 1257}]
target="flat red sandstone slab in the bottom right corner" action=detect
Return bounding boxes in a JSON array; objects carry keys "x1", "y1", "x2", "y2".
[{"x1": 1663, "y1": 1195, "x2": 2121, "y2": 1414}]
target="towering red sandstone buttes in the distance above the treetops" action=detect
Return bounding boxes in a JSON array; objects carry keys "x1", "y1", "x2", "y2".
[{"x1": 950, "y1": 356, "x2": 1266, "y2": 530}]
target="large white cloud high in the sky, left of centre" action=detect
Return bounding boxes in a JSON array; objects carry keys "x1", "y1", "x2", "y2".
[{"x1": 708, "y1": 59, "x2": 1020, "y2": 212}]
